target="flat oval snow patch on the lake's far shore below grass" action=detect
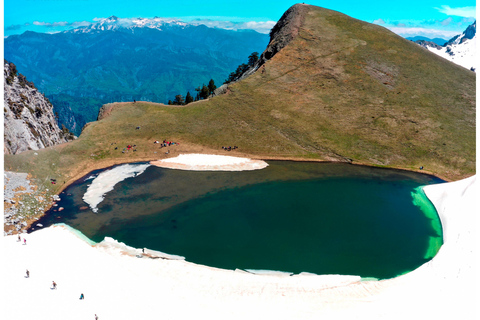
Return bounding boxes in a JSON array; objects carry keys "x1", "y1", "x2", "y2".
[{"x1": 150, "y1": 153, "x2": 268, "y2": 171}]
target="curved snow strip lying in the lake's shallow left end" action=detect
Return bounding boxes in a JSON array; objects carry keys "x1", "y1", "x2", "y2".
[{"x1": 83, "y1": 164, "x2": 150, "y2": 212}]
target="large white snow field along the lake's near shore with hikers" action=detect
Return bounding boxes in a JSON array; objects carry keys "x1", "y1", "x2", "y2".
[{"x1": 1, "y1": 177, "x2": 480, "y2": 320}]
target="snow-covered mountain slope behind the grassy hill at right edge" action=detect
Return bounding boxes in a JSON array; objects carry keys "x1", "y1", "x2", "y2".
[{"x1": 416, "y1": 21, "x2": 478, "y2": 71}]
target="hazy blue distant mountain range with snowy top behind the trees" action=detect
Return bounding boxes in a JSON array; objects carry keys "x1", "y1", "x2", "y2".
[{"x1": 4, "y1": 16, "x2": 268, "y2": 135}]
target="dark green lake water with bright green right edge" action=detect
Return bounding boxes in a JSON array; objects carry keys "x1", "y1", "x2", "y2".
[{"x1": 32, "y1": 161, "x2": 442, "y2": 279}]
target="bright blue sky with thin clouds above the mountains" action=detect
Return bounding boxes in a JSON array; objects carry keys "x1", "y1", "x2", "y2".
[{"x1": 4, "y1": 0, "x2": 476, "y2": 39}]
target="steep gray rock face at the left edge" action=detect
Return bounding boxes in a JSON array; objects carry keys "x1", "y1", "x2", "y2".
[{"x1": 3, "y1": 61, "x2": 67, "y2": 154}]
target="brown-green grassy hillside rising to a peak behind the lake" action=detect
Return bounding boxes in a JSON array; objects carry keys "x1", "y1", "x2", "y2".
[{"x1": 5, "y1": 6, "x2": 475, "y2": 220}]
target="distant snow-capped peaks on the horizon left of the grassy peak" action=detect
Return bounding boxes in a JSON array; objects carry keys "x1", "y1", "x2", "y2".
[{"x1": 64, "y1": 16, "x2": 188, "y2": 33}]
